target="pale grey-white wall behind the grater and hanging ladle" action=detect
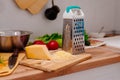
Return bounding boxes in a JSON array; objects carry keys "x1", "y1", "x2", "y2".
[{"x1": 0, "y1": 0, "x2": 119, "y2": 38}]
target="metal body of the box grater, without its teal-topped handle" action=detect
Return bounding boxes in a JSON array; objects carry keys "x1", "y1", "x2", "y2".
[{"x1": 62, "y1": 5, "x2": 85, "y2": 55}]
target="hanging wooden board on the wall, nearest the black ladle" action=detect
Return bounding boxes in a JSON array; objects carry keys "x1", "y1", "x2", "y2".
[{"x1": 28, "y1": 0, "x2": 48, "y2": 14}]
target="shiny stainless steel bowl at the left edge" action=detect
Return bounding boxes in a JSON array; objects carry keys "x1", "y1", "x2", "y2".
[{"x1": 0, "y1": 30, "x2": 32, "y2": 52}]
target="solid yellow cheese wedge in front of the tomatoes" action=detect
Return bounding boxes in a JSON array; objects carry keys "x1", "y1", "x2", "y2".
[{"x1": 25, "y1": 45, "x2": 51, "y2": 60}]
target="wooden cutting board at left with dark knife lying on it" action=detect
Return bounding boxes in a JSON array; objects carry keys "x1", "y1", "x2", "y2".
[{"x1": 0, "y1": 53, "x2": 25, "y2": 76}]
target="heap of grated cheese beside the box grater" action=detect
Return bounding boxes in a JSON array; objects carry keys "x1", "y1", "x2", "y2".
[{"x1": 52, "y1": 51, "x2": 73, "y2": 60}]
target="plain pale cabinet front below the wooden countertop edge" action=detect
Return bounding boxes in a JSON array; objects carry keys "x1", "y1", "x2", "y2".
[{"x1": 48, "y1": 62, "x2": 120, "y2": 80}]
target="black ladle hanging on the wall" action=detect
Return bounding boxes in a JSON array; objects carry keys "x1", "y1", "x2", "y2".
[{"x1": 45, "y1": 0, "x2": 60, "y2": 20}]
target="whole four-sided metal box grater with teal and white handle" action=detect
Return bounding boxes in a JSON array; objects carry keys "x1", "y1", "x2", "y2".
[{"x1": 62, "y1": 6, "x2": 85, "y2": 55}]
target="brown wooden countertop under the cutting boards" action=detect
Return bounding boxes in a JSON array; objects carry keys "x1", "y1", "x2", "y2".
[{"x1": 0, "y1": 46, "x2": 120, "y2": 80}]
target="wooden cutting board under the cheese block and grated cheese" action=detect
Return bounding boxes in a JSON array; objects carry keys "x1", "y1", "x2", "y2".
[{"x1": 20, "y1": 53, "x2": 91, "y2": 72}]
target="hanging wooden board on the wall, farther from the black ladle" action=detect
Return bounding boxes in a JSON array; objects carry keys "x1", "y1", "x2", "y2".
[{"x1": 15, "y1": 0, "x2": 37, "y2": 9}]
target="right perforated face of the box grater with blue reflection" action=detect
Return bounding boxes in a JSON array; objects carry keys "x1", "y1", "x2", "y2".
[{"x1": 72, "y1": 18, "x2": 85, "y2": 54}]
